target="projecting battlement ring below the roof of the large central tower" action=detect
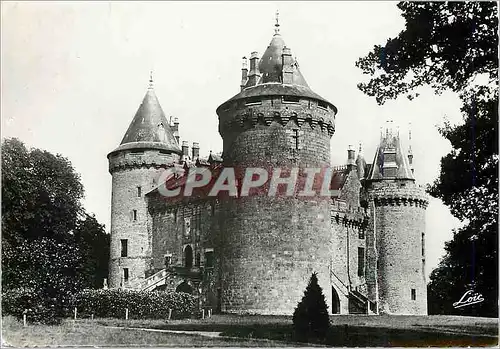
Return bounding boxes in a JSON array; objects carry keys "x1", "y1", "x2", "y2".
[{"x1": 219, "y1": 96, "x2": 335, "y2": 137}]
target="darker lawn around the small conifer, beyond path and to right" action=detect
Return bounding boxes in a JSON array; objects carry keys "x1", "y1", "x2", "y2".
[{"x1": 97, "y1": 315, "x2": 498, "y2": 347}]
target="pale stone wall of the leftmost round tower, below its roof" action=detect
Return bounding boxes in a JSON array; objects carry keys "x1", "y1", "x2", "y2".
[{"x1": 109, "y1": 150, "x2": 179, "y2": 288}]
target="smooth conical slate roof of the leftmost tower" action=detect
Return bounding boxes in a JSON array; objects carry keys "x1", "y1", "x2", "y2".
[{"x1": 112, "y1": 86, "x2": 181, "y2": 154}]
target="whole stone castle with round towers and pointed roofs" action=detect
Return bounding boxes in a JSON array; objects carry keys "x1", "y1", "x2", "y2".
[{"x1": 108, "y1": 17, "x2": 427, "y2": 315}]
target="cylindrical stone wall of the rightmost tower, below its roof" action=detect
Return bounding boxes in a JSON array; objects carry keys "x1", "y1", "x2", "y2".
[{"x1": 371, "y1": 180, "x2": 427, "y2": 315}]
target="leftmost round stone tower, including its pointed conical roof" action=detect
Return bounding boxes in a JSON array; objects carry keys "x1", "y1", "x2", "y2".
[{"x1": 108, "y1": 79, "x2": 181, "y2": 288}]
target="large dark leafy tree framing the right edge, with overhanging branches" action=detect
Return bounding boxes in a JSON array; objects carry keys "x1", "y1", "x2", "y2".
[{"x1": 356, "y1": 2, "x2": 499, "y2": 316}]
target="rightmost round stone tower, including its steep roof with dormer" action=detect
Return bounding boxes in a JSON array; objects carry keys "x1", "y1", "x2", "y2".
[{"x1": 365, "y1": 125, "x2": 428, "y2": 315}]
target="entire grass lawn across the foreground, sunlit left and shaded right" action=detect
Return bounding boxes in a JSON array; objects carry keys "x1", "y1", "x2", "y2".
[{"x1": 2, "y1": 315, "x2": 498, "y2": 347}]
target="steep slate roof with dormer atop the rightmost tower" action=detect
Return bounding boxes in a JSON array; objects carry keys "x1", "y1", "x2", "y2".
[{"x1": 366, "y1": 132, "x2": 415, "y2": 180}]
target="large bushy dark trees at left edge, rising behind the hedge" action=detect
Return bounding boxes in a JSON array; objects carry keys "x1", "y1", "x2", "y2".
[{"x1": 2, "y1": 139, "x2": 109, "y2": 320}]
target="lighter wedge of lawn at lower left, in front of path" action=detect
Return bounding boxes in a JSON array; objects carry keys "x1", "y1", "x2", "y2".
[{"x1": 2, "y1": 316, "x2": 292, "y2": 347}]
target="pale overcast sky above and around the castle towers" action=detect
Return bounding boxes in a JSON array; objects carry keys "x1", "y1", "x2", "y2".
[{"x1": 1, "y1": 1, "x2": 461, "y2": 274}]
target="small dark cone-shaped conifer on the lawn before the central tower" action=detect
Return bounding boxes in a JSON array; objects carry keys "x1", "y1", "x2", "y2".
[{"x1": 293, "y1": 273, "x2": 330, "y2": 341}]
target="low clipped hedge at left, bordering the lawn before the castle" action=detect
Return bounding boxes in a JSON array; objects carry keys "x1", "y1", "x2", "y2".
[{"x1": 2, "y1": 289, "x2": 198, "y2": 322}]
